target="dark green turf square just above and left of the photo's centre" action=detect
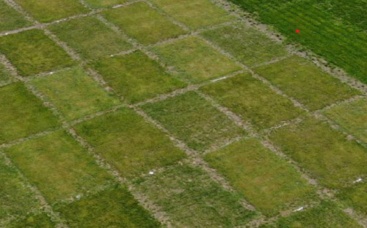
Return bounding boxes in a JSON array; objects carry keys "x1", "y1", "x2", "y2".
[{"x1": 93, "y1": 51, "x2": 186, "y2": 103}]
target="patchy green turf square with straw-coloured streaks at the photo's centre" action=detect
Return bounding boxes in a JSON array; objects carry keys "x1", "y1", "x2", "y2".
[{"x1": 142, "y1": 92, "x2": 244, "y2": 151}]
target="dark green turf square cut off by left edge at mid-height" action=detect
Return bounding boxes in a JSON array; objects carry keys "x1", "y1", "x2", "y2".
[{"x1": 0, "y1": 83, "x2": 58, "y2": 144}]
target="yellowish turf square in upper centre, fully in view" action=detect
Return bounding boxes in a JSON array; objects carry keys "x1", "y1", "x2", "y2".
[{"x1": 153, "y1": 37, "x2": 241, "y2": 82}]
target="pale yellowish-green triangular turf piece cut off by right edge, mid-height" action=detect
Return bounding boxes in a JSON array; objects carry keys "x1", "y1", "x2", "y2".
[{"x1": 324, "y1": 98, "x2": 367, "y2": 143}]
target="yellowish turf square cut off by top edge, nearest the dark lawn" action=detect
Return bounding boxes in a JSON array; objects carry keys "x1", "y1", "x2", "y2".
[{"x1": 153, "y1": 0, "x2": 234, "y2": 29}]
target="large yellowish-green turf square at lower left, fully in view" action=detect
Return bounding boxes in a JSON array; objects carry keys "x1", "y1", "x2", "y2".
[{"x1": 5, "y1": 131, "x2": 112, "y2": 203}]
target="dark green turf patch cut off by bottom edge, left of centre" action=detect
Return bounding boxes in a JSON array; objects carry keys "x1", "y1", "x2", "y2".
[{"x1": 56, "y1": 186, "x2": 160, "y2": 228}]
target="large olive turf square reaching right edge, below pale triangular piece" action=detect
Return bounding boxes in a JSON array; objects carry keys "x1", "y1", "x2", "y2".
[{"x1": 270, "y1": 118, "x2": 367, "y2": 189}]
